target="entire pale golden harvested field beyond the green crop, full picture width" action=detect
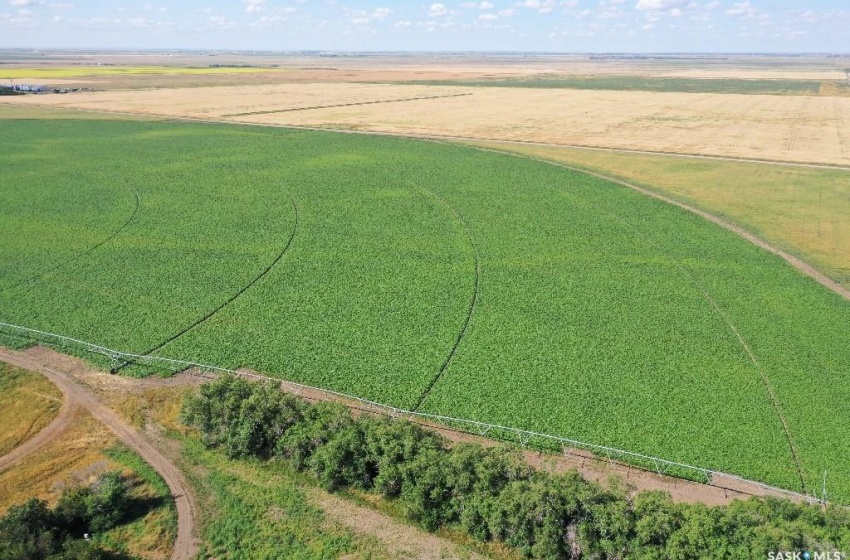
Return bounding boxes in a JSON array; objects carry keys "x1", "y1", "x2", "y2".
[{"x1": 2, "y1": 83, "x2": 850, "y2": 166}]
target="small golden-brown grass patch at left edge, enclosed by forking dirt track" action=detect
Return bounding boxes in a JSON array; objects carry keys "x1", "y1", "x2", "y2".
[{"x1": 0, "y1": 363, "x2": 62, "y2": 456}]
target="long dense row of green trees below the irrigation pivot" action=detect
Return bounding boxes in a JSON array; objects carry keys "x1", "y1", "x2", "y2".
[{"x1": 181, "y1": 376, "x2": 850, "y2": 560}]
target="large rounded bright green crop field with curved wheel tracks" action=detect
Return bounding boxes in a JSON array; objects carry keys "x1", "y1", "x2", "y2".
[{"x1": 0, "y1": 116, "x2": 850, "y2": 502}]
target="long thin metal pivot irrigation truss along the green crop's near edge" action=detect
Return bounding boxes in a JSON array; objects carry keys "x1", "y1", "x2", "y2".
[{"x1": 0, "y1": 322, "x2": 827, "y2": 505}]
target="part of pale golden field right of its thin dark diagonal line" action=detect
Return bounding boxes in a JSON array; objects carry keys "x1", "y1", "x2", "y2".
[{"x1": 240, "y1": 88, "x2": 850, "y2": 165}]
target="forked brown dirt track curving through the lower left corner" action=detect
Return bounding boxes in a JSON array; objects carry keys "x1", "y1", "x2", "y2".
[{"x1": 0, "y1": 348, "x2": 198, "y2": 560}]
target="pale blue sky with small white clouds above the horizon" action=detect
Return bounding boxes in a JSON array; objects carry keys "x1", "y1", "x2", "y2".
[{"x1": 0, "y1": 0, "x2": 850, "y2": 53}]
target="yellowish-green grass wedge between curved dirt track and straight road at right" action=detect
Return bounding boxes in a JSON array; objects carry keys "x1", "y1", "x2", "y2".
[{"x1": 468, "y1": 143, "x2": 850, "y2": 287}]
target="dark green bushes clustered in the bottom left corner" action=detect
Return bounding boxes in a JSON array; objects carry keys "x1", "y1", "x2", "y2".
[{"x1": 0, "y1": 472, "x2": 129, "y2": 560}]
